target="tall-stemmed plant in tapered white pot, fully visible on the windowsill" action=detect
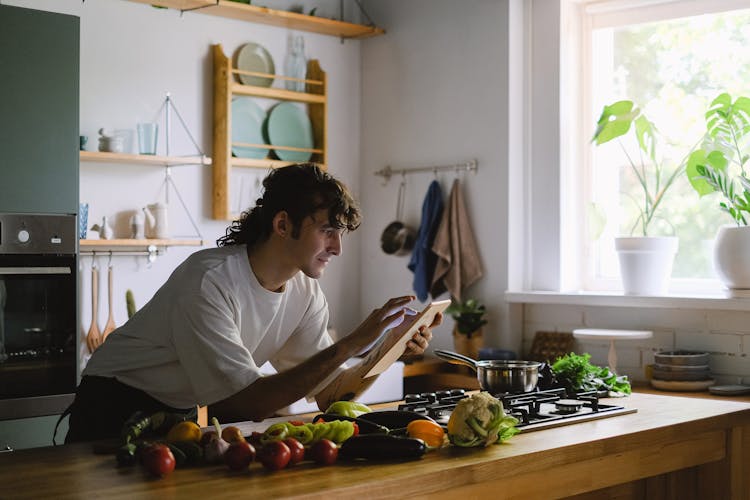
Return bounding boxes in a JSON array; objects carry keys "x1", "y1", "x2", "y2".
[{"x1": 592, "y1": 100, "x2": 685, "y2": 295}]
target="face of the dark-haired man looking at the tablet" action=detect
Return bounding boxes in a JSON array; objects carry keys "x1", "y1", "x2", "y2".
[{"x1": 287, "y1": 209, "x2": 343, "y2": 278}]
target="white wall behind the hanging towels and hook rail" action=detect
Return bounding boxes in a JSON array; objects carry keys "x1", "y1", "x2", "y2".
[{"x1": 360, "y1": 0, "x2": 520, "y2": 348}]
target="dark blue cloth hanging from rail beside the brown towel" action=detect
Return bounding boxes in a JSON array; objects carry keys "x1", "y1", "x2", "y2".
[{"x1": 408, "y1": 181, "x2": 443, "y2": 302}]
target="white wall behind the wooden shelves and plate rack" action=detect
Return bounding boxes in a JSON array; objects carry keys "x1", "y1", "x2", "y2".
[{"x1": 3, "y1": 0, "x2": 364, "y2": 370}]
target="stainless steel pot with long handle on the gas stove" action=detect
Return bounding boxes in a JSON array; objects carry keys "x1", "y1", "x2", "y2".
[{"x1": 435, "y1": 349, "x2": 541, "y2": 394}]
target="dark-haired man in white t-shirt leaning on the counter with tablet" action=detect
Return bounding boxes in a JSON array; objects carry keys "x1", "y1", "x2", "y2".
[{"x1": 66, "y1": 164, "x2": 442, "y2": 442}]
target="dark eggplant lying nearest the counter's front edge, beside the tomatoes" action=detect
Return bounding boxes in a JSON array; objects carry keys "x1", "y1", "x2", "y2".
[{"x1": 338, "y1": 434, "x2": 427, "y2": 460}]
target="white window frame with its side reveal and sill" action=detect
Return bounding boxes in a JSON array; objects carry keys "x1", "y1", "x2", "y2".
[{"x1": 506, "y1": 0, "x2": 750, "y2": 309}]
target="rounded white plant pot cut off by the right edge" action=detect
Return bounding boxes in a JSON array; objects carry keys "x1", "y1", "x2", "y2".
[{"x1": 714, "y1": 226, "x2": 750, "y2": 295}]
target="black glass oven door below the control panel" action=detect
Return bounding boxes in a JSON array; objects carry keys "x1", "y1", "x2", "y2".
[{"x1": 0, "y1": 254, "x2": 77, "y2": 419}]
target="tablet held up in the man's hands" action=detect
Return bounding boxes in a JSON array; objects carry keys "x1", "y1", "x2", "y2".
[{"x1": 362, "y1": 300, "x2": 451, "y2": 378}]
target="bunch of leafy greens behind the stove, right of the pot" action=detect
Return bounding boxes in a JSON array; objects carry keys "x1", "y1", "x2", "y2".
[{"x1": 551, "y1": 352, "x2": 631, "y2": 397}]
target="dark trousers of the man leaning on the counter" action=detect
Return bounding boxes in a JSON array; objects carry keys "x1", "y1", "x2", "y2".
[{"x1": 61, "y1": 376, "x2": 191, "y2": 443}]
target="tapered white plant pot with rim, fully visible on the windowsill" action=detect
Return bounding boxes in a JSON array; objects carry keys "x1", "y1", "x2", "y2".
[{"x1": 615, "y1": 236, "x2": 679, "y2": 295}]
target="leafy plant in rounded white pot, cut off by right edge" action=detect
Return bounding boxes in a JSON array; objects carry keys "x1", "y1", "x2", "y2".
[{"x1": 686, "y1": 93, "x2": 750, "y2": 295}]
